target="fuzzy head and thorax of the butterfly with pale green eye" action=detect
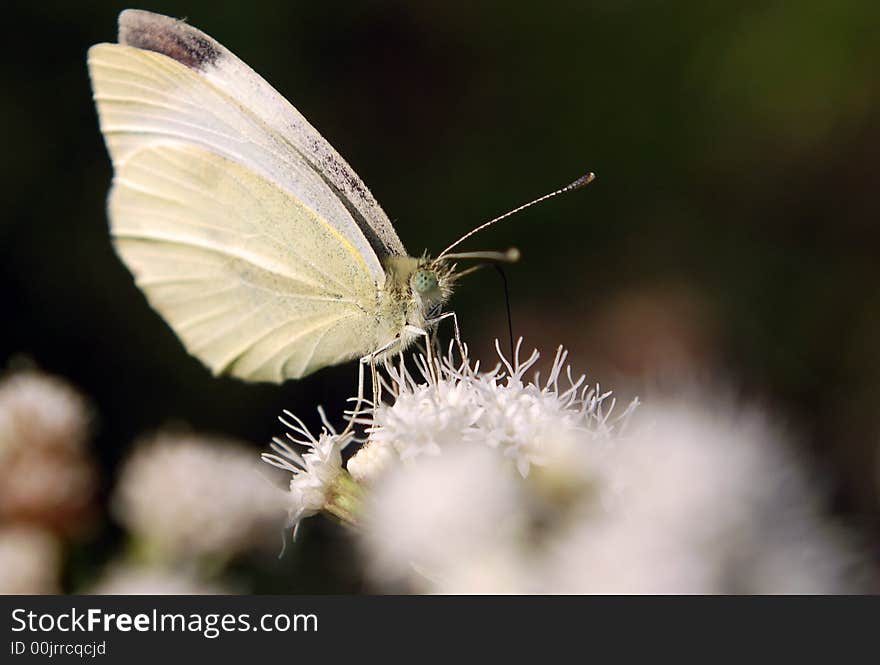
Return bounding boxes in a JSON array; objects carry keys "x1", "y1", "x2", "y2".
[{"x1": 376, "y1": 256, "x2": 452, "y2": 355}]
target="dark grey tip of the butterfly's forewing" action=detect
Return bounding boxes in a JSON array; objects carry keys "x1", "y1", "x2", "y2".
[{"x1": 118, "y1": 9, "x2": 223, "y2": 70}]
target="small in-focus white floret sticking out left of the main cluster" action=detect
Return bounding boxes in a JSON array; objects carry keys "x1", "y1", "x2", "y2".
[{"x1": 262, "y1": 409, "x2": 359, "y2": 536}]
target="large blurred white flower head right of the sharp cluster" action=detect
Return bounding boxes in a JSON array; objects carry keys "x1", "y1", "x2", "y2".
[{"x1": 544, "y1": 400, "x2": 859, "y2": 593}]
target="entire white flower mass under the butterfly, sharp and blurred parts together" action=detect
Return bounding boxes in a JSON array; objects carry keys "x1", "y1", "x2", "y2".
[{"x1": 264, "y1": 344, "x2": 863, "y2": 593}]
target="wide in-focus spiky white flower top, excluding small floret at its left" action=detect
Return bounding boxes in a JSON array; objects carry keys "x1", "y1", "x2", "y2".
[{"x1": 355, "y1": 340, "x2": 637, "y2": 477}]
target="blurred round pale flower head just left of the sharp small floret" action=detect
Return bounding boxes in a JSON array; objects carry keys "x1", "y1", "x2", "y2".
[{"x1": 113, "y1": 434, "x2": 286, "y2": 559}]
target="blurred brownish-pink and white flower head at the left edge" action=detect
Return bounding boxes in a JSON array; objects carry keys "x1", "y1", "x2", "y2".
[{"x1": 0, "y1": 371, "x2": 96, "y2": 532}]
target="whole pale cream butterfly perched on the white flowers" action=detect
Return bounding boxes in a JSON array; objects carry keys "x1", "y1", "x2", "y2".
[{"x1": 88, "y1": 10, "x2": 592, "y2": 382}]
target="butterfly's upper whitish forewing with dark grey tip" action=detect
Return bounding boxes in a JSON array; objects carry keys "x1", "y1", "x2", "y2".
[{"x1": 90, "y1": 10, "x2": 406, "y2": 258}]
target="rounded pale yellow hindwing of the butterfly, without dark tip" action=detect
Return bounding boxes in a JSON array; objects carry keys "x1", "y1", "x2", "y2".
[{"x1": 109, "y1": 143, "x2": 376, "y2": 381}]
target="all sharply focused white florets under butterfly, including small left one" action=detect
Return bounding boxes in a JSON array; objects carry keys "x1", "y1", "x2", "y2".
[{"x1": 274, "y1": 340, "x2": 636, "y2": 558}]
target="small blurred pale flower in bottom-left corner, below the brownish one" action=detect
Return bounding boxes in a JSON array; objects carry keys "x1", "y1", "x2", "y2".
[{"x1": 0, "y1": 526, "x2": 61, "y2": 594}]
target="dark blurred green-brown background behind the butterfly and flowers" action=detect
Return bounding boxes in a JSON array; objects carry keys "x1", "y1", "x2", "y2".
[{"x1": 0, "y1": 0, "x2": 880, "y2": 592}]
